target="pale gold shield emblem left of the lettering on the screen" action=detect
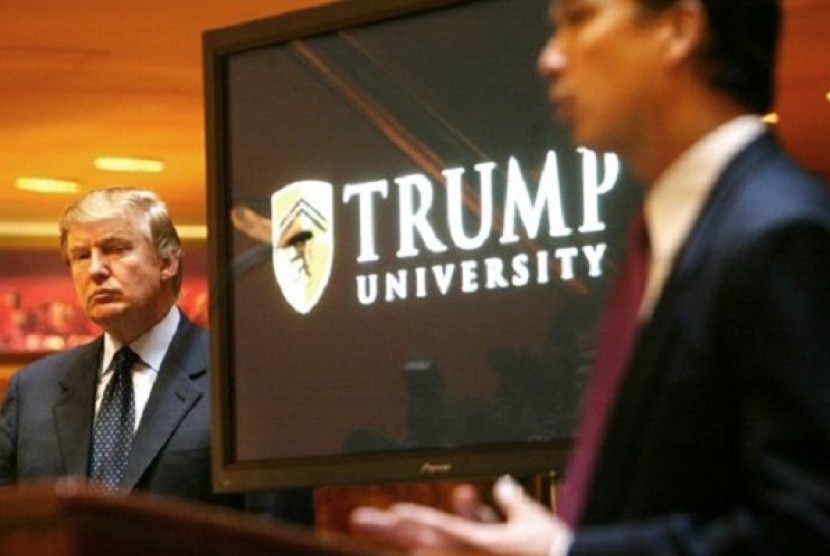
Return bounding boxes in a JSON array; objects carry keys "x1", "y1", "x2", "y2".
[{"x1": 271, "y1": 181, "x2": 334, "y2": 314}]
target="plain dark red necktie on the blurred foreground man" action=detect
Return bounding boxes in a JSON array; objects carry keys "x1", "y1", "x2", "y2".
[{"x1": 559, "y1": 213, "x2": 649, "y2": 526}]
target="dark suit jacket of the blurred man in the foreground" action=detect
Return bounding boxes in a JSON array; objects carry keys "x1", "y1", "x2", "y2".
[{"x1": 570, "y1": 136, "x2": 830, "y2": 556}]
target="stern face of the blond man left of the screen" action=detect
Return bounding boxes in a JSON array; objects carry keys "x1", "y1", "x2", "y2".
[{"x1": 66, "y1": 213, "x2": 178, "y2": 333}]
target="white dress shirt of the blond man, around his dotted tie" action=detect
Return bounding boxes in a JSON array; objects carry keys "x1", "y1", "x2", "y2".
[{"x1": 95, "y1": 306, "x2": 181, "y2": 430}]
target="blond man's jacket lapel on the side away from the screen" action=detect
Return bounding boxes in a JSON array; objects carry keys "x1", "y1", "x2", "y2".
[{"x1": 52, "y1": 339, "x2": 103, "y2": 476}]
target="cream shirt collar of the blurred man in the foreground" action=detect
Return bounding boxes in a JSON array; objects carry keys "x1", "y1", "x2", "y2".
[{"x1": 645, "y1": 115, "x2": 766, "y2": 264}]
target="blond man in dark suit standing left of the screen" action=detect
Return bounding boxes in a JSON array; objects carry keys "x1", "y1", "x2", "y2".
[{"x1": 0, "y1": 188, "x2": 236, "y2": 503}]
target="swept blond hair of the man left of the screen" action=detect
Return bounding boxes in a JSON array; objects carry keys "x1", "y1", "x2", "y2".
[{"x1": 58, "y1": 187, "x2": 182, "y2": 295}]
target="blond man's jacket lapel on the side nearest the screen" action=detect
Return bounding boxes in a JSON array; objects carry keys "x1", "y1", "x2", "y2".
[{"x1": 124, "y1": 315, "x2": 207, "y2": 487}]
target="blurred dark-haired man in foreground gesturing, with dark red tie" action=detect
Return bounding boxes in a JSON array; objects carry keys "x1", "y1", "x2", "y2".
[{"x1": 352, "y1": 0, "x2": 830, "y2": 556}]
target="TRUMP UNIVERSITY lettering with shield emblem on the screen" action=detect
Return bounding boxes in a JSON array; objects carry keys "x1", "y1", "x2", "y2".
[{"x1": 271, "y1": 147, "x2": 620, "y2": 314}]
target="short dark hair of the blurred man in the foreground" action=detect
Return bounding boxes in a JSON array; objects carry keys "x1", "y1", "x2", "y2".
[{"x1": 637, "y1": 0, "x2": 781, "y2": 114}]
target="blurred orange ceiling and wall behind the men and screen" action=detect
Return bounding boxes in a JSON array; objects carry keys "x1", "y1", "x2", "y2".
[{"x1": 0, "y1": 0, "x2": 830, "y2": 245}]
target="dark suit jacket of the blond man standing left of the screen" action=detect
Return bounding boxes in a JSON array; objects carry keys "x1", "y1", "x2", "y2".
[{"x1": 0, "y1": 315, "x2": 235, "y2": 503}]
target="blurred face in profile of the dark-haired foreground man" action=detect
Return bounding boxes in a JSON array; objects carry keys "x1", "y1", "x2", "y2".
[{"x1": 538, "y1": 0, "x2": 676, "y2": 151}]
